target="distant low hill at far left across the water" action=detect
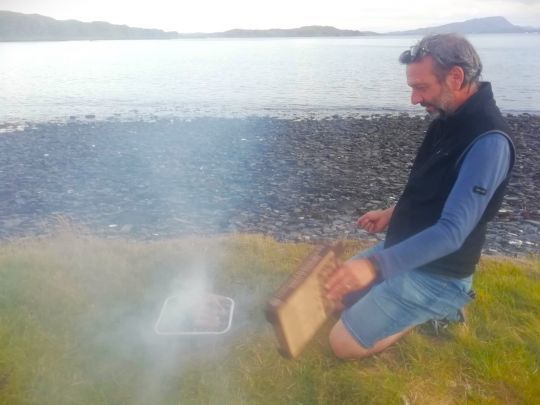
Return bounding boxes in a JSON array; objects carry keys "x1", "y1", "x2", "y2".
[{"x1": 0, "y1": 11, "x2": 178, "y2": 41}]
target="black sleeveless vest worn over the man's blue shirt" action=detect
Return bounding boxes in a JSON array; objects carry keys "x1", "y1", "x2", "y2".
[{"x1": 385, "y1": 82, "x2": 514, "y2": 278}]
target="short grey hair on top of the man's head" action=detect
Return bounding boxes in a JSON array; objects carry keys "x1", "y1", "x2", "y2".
[{"x1": 399, "y1": 34, "x2": 482, "y2": 86}]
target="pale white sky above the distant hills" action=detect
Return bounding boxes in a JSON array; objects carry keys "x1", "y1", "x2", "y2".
[{"x1": 0, "y1": 0, "x2": 540, "y2": 33}]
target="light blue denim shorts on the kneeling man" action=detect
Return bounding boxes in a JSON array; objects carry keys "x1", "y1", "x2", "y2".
[{"x1": 341, "y1": 242, "x2": 472, "y2": 348}]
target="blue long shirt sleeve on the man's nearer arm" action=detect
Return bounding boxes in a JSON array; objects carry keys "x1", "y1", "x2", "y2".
[{"x1": 368, "y1": 132, "x2": 511, "y2": 278}]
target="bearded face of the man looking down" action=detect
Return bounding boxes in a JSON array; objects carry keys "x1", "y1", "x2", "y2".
[{"x1": 407, "y1": 56, "x2": 454, "y2": 115}]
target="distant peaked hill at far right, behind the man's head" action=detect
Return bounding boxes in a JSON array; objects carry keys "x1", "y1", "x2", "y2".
[{"x1": 387, "y1": 17, "x2": 540, "y2": 35}]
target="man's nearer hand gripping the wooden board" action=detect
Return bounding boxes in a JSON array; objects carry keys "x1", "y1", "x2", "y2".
[{"x1": 324, "y1": 259, "x2": 377, "y2": 301}]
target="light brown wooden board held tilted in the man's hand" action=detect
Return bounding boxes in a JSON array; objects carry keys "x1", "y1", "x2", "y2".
[{"x1": 265, "y1": 242, "x2": 343, "y2": 358}]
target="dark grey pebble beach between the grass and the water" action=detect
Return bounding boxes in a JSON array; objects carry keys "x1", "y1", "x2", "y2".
[{"x1": 0, "y1": 113, "x2": 540, "y2": 255}]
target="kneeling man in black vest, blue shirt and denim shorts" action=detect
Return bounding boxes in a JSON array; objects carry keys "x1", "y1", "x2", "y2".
[{"x1": 326, "y1": 34, "x2": 514, "y2": 358}]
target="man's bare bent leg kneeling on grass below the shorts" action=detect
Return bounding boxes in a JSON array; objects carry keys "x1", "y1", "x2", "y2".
[{"x1": 330, "y1": 320, "x2": 412, "y2": 359}]
